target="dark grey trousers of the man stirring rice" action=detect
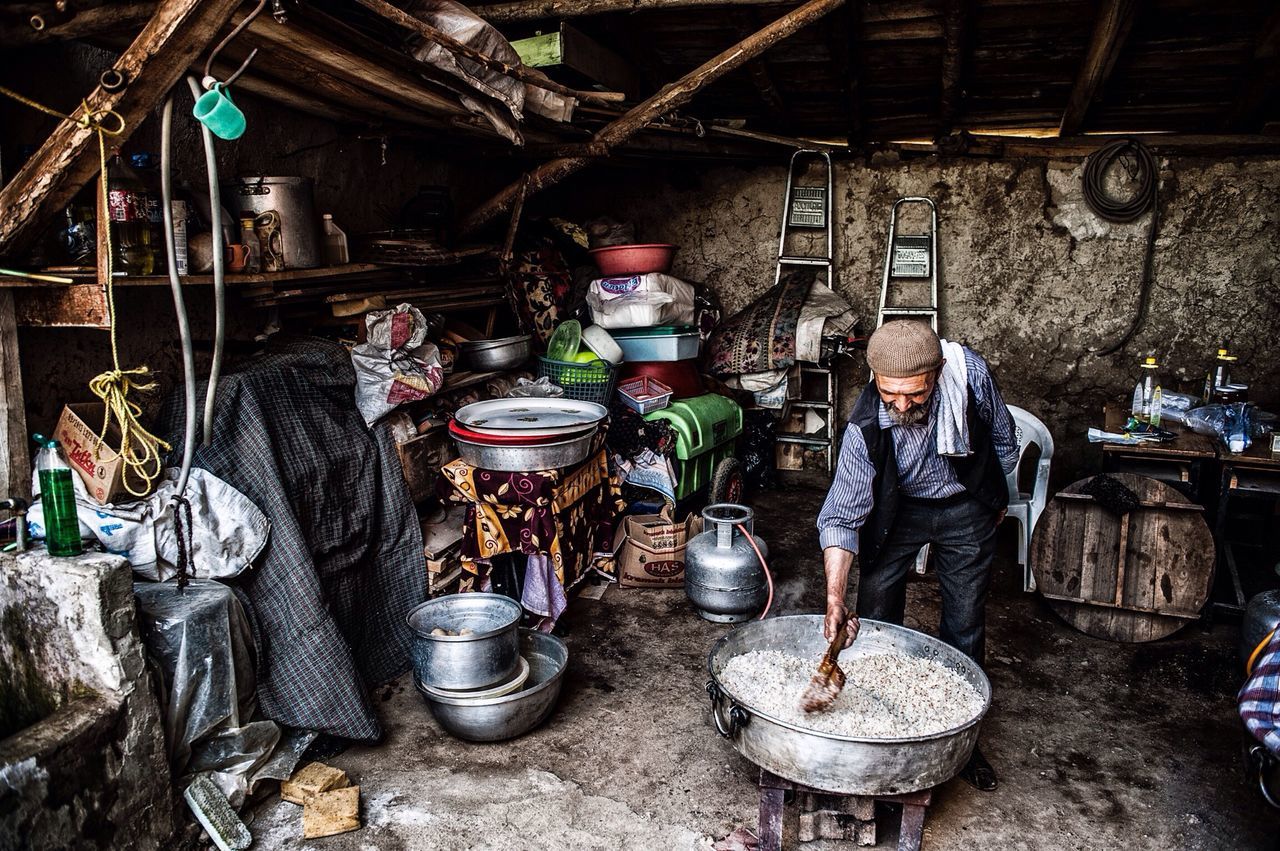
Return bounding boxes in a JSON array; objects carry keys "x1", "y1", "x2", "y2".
[{"x1": 856, "y1": 497, "x2": 996, "y2": 665}]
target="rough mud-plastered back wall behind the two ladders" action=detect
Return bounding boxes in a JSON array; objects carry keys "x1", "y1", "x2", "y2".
[{"x1": 555, "y1": 154, "x2": 1280, "y2": 482}]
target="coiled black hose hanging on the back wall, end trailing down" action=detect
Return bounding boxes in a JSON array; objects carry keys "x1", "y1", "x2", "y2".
[{"x1": 1082, "y1": 138, "x2": 1160, "y2": 357}]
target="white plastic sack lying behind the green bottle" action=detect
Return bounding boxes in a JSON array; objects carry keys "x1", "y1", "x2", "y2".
[{"x1": 27, "y1": 467, "x2": 271, "y2": 581}]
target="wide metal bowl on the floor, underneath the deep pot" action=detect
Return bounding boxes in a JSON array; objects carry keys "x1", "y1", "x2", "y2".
[{"x1": 419, "y1": 630, "x2": 568, "y2": 742}]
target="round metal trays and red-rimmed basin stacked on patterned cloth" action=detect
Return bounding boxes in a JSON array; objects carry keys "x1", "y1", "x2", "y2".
[{"x1": 449, "y1": 398, "x2": 608, "y2": 472}]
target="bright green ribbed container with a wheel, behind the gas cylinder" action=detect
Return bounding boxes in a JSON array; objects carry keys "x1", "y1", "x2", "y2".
[{"x1": 644, "y1": 393, "x2": 742, "y2": 500}]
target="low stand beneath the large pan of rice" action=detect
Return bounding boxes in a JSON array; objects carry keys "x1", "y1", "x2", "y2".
[{"x1": 759, "y1": 768, "x2": 933, "y2": 851}]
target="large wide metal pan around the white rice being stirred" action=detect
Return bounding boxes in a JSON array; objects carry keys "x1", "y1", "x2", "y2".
[{"x1": 707, "y1": 614, "x2": 991, "y2": 795}]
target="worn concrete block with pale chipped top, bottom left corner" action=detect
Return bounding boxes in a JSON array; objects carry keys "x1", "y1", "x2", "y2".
[{"x1": 0, "y1": 549, "x2": 175, "y2": 851}]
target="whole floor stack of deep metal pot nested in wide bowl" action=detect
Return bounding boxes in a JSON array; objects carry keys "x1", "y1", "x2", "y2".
[{"x1": 408, "y1": 594, "x2": 568, "y2": 742}]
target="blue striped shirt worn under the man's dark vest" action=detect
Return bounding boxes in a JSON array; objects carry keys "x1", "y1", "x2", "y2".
[{"x1": 818, "y1": 347, "x2": 1018, "y2": 553}]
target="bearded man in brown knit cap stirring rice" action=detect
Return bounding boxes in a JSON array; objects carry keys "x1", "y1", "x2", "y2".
[{"x1": 818, "y1": 320, "x2": 1018, "y2": 791}]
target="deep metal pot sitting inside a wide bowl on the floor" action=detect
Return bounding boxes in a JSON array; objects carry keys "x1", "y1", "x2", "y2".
[{"x1": 408, "y1": 593, "x2": 524, "y2": 690}]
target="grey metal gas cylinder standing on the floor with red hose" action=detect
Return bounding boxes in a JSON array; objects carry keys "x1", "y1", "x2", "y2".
[{"x1": 685, "y1": 503, "x2": 769, "y2": 623}]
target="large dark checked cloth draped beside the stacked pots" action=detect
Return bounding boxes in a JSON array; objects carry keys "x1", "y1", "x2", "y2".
[{"x1": 160, "y1": 339, "x2": 426, "y2": 741}]
